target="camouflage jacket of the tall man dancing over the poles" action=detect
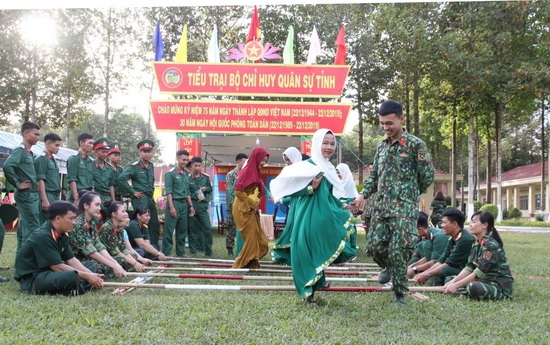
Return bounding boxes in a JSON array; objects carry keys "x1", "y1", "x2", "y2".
[{"x1": 361, "y1": 132, "x2": 434, "y2": 218}]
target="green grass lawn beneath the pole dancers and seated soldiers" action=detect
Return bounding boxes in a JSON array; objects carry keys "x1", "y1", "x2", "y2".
[{"x1": 0, "y1": 227, "x2": 550, "y2": 344}]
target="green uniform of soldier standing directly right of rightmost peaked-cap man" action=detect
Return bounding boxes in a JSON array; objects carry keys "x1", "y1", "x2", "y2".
[{"x1": 162, "y1": 167, "x2": 190, "y2": 256}]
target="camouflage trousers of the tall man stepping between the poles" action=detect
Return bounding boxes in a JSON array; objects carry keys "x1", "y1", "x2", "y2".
[{"x1": 367, "y1": 216, "x2": 418, "y2": 294}]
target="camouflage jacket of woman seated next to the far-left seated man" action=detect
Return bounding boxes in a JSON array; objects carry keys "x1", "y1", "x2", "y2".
[{"x1": 69, "y1": 214, "x2": 106, "y2": 261}]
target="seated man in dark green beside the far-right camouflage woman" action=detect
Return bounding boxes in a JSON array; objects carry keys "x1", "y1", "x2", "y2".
[{"x1": 413, "y1": 208, "x2": 475, "y2": 285}]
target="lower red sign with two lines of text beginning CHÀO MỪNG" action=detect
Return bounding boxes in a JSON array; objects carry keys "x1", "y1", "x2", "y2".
[{"x1": 149, "y1": 100, "x2": 352, "y2": 135}]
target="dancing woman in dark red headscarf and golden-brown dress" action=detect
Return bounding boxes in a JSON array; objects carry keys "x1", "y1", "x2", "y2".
[{"x1": 232, "y1": 147, "x2": 269, "y2": 268}]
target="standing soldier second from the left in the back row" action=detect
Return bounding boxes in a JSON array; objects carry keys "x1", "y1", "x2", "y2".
[{"x1": 34, "y1": 133, "x2": 61, "y2": 223}]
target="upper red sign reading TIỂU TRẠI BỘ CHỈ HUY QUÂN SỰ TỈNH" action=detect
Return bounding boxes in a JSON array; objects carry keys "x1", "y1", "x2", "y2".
[{"x1": 153, "y1": 62, "x2": 349, "y2": 98}]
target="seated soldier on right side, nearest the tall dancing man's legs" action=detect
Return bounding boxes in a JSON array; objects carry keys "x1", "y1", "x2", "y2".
[{"x1": 407, "y1": 212, "x2": 449, "y2": 278}]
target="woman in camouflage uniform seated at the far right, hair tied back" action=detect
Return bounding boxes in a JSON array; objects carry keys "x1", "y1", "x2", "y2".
[{"x1": 445, "y1": 211, "x2": 514, "y2": 301}]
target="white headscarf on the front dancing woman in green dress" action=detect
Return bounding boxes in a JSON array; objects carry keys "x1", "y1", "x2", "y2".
[{"x1": 269, "y1": 128, "x2": 343, "y2": 201}]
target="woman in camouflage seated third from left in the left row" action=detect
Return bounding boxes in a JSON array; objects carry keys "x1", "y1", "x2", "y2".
[{"x1": 99, "y1": 201, "x2": 149, "y2": 272}]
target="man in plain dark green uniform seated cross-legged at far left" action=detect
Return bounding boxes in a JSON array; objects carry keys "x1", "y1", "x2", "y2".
[{"x1": 14, "y1": 201, "x2": 103, "y2": 295}]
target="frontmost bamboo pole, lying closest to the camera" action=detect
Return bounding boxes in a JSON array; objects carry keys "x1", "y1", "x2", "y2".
[{"x1": 103, "y1": 282, "x2": 444, "y2": 292}]
